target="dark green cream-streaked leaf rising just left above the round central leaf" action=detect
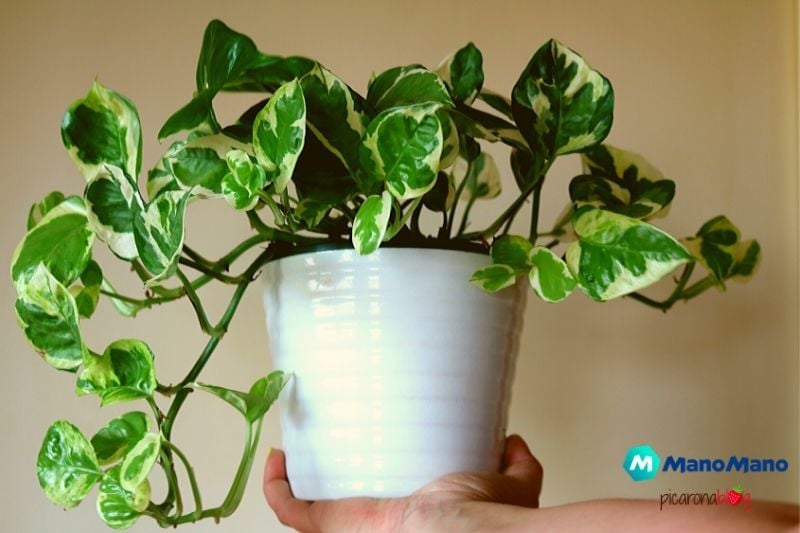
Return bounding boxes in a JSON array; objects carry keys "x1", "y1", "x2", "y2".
[{"x1": 300, "y1": 64, "x2": 369, "y2": 173}]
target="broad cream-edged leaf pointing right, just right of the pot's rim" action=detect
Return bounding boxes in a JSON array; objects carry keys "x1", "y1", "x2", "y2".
[{"x1": 566, "y1": 208, "x2": 692, "y2": 301}]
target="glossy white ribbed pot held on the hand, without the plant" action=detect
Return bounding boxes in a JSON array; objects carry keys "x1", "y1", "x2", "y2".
[{"x1": 264, "y1": 248, "x2": 526, "y2": 500}]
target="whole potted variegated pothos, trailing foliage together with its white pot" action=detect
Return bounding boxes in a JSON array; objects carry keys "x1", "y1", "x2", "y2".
[{"x1": 11, "y1": 21, "x2": 759, "y2": 529}]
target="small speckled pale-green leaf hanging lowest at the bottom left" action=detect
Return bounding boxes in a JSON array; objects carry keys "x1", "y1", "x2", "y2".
[{"x1": 97, "y1": 466, "x2": 150, "y2": 529}]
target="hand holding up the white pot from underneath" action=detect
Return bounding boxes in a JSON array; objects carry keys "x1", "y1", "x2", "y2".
[{"x1": 264, "y1": 435, "x2": 542, "y2": 533}]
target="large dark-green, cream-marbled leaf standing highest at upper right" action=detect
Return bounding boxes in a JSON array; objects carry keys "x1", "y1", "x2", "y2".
[{"x1": 512, "y1": 39, "x2": 614, "y2": 159}]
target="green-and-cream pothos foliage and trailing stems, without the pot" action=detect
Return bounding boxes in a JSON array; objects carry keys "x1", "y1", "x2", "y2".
[{"x1": 11, "y1": 21, "x2": 759, "y2": 529}]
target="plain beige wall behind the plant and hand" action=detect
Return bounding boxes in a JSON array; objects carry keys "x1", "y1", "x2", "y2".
[{"x1": 0, "y1": 0, "x2": 798, "y2": 532}]
